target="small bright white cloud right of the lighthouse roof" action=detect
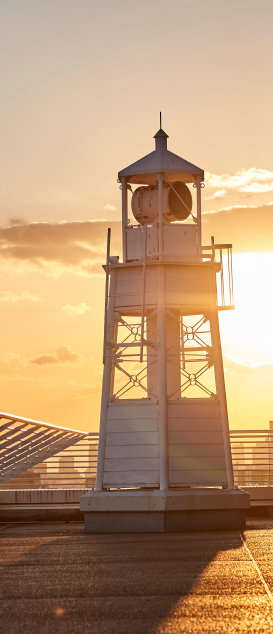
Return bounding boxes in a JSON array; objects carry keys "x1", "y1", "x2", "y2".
[{"x1": 206, "y1": 167, "x2": 273, "y2": 193}]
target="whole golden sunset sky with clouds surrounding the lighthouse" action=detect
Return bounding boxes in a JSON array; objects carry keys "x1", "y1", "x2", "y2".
[{"x1": 0, "y1": 0, "x2": 273, "y2": 431}]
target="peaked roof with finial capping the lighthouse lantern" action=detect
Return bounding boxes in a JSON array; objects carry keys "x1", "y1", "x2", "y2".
[{"x1": 118, "y1": 128, "x2": 204, "y2": 185}]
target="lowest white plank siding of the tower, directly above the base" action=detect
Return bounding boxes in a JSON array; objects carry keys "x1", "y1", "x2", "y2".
[{"x1": 103, "y1": 398, "x2": 226, "y2": 487}]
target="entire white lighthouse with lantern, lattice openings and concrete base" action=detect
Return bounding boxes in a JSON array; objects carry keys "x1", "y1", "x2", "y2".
[{"x1": 81, "y1": 125, "x2": 249, "y2": 532}]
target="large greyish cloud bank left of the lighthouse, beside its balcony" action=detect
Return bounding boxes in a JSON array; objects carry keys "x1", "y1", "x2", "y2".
[{"x1": 0, "y1": 220, "x2": 121, "y2": 276}]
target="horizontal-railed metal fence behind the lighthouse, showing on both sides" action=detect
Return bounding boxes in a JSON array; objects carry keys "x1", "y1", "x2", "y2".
[{"x1": 0, "y1": 430, "x2": 273, "y2": 490}]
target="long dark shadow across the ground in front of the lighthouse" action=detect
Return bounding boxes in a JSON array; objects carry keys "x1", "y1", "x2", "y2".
[{"x1": 0, "y1": 523, "x2": 250, "y2": 634}]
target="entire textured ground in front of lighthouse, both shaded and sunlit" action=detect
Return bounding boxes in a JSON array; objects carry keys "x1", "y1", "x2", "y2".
[{"x1": 0, "y1": 519, "x2": 273, "y2": 634}]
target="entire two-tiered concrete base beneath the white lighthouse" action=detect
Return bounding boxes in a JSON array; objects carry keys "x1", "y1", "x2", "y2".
[{"x1": 80, "y1": 489, "x2": 250, "y2": 533}]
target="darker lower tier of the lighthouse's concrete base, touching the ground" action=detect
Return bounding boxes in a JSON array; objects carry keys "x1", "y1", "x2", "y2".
[{"x1": 84, "y1": 509, "x2": 246, "y2": 533}]
